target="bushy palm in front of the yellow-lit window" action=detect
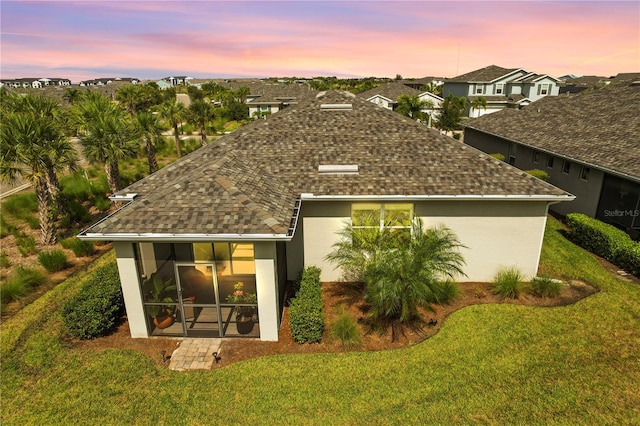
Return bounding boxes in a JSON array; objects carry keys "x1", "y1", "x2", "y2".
[{"x1": 327, "y1": 217, "x2": 464, "y2": 322}]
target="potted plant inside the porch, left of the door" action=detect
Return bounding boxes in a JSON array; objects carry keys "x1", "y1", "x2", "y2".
[{"x1": 142, "y1": 272, "x2": 177, "y2": 329}]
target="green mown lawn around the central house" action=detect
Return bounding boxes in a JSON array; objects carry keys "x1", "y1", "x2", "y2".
[{"x1": 0, "y1": 219, "x2": 640, "y2": 425}]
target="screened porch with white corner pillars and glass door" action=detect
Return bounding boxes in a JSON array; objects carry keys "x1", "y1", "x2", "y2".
[{"x1": 114, "y1": 241, "x2": 286, "y2": 340}]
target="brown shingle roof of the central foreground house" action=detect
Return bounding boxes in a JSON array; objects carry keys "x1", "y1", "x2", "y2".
[{"x1": 82, "y1": 91, "x2": 565, "y2": 238}]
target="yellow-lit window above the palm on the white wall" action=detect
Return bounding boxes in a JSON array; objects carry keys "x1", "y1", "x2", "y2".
[{"x1": 351, "y1": 203, "x2": 413, "y2": 236}]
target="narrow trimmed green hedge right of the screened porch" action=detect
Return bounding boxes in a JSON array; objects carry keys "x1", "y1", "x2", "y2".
[{"x1": 289, "y1": 266, "x2": 324, "y2": 343}]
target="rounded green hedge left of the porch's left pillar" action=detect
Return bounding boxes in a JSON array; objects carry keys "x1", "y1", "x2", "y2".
[{"x1": 62, "y1": 263, "x2": 124, "y2": 340}]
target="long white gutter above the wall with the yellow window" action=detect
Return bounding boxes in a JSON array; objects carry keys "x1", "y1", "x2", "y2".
[{"x1": 300, "y1": 193, "x2": 576, "y2": 203}]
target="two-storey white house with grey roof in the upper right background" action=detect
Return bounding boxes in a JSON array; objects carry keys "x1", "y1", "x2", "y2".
[{"x1": 442, "y1": 65, "x2": 560, "y2": 117}]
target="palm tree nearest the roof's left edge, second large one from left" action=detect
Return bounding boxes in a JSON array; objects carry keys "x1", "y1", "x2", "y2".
[{"x1": 75, "y1": 94, "x2": 136, "y2": 193}]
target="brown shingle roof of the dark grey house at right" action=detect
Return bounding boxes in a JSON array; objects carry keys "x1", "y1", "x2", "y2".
[{"x1": 466, "y1": 83, "x2": 640, "y2": 180}]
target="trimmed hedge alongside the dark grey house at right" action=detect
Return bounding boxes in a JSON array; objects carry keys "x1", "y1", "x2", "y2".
[{"x1": 565, "y1": 213, "x2": 640, "y2": 275}]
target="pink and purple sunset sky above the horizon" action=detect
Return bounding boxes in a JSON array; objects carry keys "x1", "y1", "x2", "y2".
[{"x1": 0, "y1": 0, "x2": 640, "y2": 83}]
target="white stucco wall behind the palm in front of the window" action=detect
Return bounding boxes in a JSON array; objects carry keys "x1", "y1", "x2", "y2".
[{"x1": 302, "y1": 201, "x2": 547, "y2": 281}]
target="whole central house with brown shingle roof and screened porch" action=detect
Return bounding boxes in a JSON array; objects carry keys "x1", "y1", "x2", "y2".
[{"x1": 79, "y1": 91, "x2": 573, "y2": 340}]
